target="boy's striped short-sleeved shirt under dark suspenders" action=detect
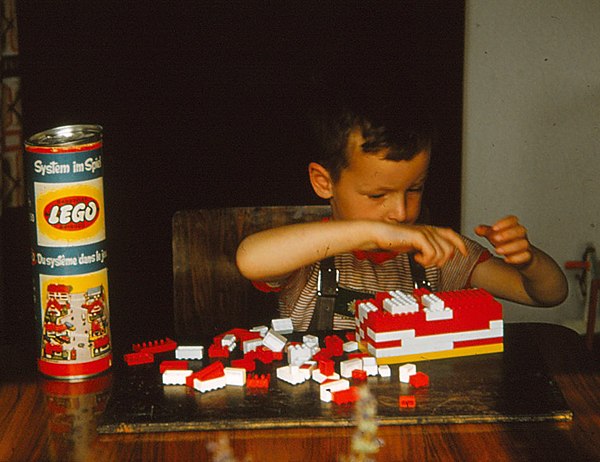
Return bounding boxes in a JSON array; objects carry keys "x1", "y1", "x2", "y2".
[{"x1": 258, "y1": 236, "x2": 487, "y2": 332}]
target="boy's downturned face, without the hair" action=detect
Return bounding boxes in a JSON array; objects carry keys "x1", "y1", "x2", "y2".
[{"x1": 313, "y1": 129, "x2": 430, "y2": 224}]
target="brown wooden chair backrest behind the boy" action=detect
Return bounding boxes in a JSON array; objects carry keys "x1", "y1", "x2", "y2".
[{"x1": 172, "y1": 206, "x2": 331, "y2": 340}]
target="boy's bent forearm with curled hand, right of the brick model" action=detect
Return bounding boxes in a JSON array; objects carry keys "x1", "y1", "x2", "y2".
[{"x1": 471, "y1": 216, "x2": 568, "y2": 306}]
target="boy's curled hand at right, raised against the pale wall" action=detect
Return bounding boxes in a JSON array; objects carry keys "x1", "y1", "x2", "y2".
[{"x1": 475, "y1": 215, "x2": 533, "y2": 266}]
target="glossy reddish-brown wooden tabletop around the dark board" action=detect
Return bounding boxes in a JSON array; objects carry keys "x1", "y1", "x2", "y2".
[{"x1": 0, "y1": 324, "x2": 600, "y2": 462}]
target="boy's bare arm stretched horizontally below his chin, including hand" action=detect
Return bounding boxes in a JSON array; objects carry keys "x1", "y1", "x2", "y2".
[{"x1": 236, "y1": 220, "x2": 467, "y2": 281}]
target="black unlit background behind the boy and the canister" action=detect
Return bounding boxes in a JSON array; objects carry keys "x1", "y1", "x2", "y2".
[{"x1": 10, "y1": 0, "x2": 464, "y2": 344}]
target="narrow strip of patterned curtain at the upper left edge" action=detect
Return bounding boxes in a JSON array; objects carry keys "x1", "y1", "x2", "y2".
[{"x1": 0, "y1": 0, "x2": 25, "y2": 216}]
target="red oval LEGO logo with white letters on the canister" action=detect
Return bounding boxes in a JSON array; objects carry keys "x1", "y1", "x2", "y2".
[{"x1": 44, "y1": 196, "x2": 99, "y2": 231}]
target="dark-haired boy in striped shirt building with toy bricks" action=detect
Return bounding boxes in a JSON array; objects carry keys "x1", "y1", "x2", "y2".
[{"x1": 237, "y1": 96, "x2": 567, "y2": 331}]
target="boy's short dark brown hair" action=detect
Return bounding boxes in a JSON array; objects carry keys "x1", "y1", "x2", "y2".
[{"x1": 312, "y1": 90, "x2": 435, "y2": 182}]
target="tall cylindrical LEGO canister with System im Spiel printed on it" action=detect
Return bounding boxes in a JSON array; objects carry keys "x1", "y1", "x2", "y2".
[{"x1": 25, "y1": 125, "x2": 112, "y2": 380}]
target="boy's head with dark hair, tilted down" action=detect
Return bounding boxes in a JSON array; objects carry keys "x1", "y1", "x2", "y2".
[{"x1": 309, "y1": 90, "x2": 433, "y2": 223}]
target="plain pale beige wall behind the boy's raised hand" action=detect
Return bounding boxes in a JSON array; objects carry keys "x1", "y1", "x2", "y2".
[{"x1": 462, "y1": 0, "x2": 600, "y2": 330}]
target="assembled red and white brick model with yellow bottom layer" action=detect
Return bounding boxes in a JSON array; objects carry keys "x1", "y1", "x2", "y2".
[{"x1": 355, "y1": 289, "x2": 504, "y2": 364}]
